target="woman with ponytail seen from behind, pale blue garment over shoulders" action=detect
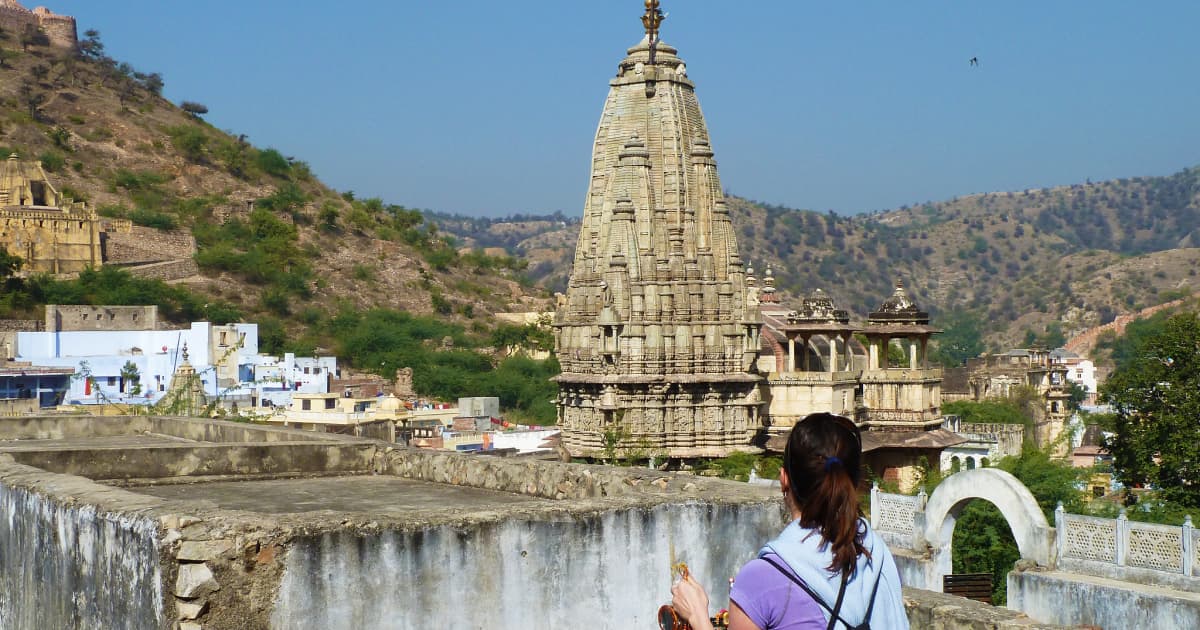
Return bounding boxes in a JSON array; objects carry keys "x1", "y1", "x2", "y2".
[{"x1": 671, "y1": 414, "x2": 908, "y2": 630}]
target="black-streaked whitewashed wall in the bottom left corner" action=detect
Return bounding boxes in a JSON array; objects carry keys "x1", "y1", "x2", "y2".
[{"x1": 0, "y1": 455, "x2": 169, "y2": 630}]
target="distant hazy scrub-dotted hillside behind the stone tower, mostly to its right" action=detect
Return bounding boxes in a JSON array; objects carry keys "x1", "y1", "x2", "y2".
[{"x1": 443, "y1": 168, "x2": 1200, "y2": 349}]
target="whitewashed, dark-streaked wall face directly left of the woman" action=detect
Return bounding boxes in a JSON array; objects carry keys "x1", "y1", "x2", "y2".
[{"x1": 271, "y1": 504, "x2": 780, "y2": 630}]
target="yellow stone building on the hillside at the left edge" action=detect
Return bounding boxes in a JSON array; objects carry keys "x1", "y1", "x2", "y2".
[{"x1": 0, "y1": 154, "x2": 132, "y2": 274}]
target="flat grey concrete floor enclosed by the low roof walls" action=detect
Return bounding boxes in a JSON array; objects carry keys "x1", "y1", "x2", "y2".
[{"x1": 130, "y1": 475, "x2": 556, "y2": 515}]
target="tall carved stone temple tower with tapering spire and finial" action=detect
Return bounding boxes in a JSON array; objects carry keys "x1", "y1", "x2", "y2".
[{"x1": 554, "y1": 0, "x2": 762, "y2": 457}]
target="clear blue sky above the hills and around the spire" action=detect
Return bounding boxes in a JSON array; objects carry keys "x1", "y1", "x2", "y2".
[{"x1": 46, "y1": 0, "x2": 1200, "y2": 216}]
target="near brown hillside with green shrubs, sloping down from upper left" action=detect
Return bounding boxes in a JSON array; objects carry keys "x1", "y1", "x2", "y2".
[{"x1": 0, "y1": 31, "x2": 545, "y2": 349}]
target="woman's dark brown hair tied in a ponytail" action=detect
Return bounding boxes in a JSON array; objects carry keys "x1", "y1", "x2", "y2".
[{"x1": 784, "y1": 413, "x2": 869, "y2": 572}]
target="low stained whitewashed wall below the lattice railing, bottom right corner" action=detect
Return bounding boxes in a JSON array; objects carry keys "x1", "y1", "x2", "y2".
[{"x1": 1008, "y1": 571, "x2": 1200, "y2": 628}]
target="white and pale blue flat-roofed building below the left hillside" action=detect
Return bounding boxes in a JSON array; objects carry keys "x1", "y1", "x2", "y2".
[{"x1": 7, "y1": 305, "x2": 337, "y2": 413}]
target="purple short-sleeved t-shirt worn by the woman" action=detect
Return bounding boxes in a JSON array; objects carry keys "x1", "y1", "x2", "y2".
[{"x1": 730, "y1": 553, "x2": 829, "y2": 630}]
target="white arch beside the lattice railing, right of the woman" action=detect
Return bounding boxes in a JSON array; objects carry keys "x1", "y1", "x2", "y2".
[{"x1": 925, "y1": 468, "x2": 1055, "y2": 573}]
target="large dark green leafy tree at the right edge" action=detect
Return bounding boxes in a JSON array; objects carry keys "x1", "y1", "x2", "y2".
[{"x1": 1100, "y1": 313, "x2": 1200, "y2": 508}]
